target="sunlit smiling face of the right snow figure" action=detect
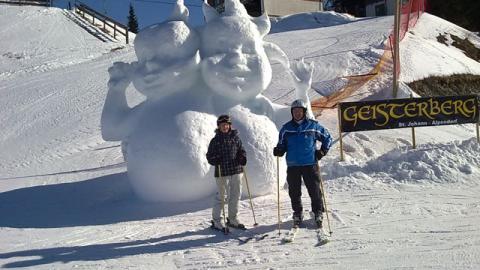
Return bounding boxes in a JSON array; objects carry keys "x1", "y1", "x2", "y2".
[{"x1": 201, "y1": 16, "x2": 272, "y2": 101}]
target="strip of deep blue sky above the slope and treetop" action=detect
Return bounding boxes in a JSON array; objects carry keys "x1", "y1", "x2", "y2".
[{"x1": 53, "y1": 0, "x2": 203, "y2": 29}]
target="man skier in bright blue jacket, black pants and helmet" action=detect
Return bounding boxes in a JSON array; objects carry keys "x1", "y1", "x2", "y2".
[{"x1": 273, "y1": 99, "x2": 332, "y2": 229}]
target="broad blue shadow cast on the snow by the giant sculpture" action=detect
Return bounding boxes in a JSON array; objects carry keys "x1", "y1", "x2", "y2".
[{"x1": 0, "y1": 173, "x2": 211, "y2": 228}]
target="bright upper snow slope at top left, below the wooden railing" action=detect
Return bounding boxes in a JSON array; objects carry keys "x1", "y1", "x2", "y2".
[{"x1": 0, "y1": 5, "x2": 125, "y2": 80}]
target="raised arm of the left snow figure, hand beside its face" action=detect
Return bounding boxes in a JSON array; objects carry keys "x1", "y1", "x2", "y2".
[{"x1": 100, "y1": 62, "x2": 132, "y2": 141}]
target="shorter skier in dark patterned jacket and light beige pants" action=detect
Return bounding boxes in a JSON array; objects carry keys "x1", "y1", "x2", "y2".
[{"x1": 207, "y1": 115, "x2": 247, "y2": 232}]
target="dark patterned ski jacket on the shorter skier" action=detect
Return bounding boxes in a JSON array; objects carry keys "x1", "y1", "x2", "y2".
[{"x1": 207, "y1": 130, "x2": 247, "y2": 177}]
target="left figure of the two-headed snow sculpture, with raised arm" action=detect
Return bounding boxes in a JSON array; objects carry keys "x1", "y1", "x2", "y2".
[{"x1": 101, "y1": 1, "x2": 216, "y2": 201}]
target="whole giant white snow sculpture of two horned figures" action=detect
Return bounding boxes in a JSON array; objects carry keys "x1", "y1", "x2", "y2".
[{"x1": 101, "y1": 0, "x2": 313, "y2": 201}]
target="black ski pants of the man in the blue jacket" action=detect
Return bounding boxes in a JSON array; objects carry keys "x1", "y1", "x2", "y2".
[{"x1": 287, "y1": 164, "x2": 325, "y2": 216}]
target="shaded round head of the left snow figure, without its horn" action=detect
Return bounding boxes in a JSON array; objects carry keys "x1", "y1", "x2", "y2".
[{"x1": 133, "y1": 21, "x2": 200, "y2": 99}]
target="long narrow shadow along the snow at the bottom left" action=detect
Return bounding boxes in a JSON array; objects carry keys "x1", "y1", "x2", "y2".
[{"x1": 0, "y1": 228, "x2": 229, "y2": 268}]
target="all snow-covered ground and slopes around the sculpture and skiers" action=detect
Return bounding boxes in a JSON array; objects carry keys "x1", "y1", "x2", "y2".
[{"x1": 0, "y1": 5, "x2": 480, "y2": 269}]
